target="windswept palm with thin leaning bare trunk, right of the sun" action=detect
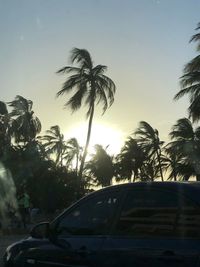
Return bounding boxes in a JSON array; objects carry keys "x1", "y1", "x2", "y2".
[{"x1": 135, "y1": 121, "x2": 164, "y2": 181}]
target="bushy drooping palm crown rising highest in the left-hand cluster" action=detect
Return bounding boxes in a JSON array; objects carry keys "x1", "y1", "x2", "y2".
[{"x1": 8, "y1": 95, "x2": 41, "y2": 144}]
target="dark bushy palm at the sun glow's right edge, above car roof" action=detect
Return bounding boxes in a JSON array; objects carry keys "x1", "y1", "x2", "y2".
[{"x1": 115, "y1": 137, "x2": 146, "y2": 182}]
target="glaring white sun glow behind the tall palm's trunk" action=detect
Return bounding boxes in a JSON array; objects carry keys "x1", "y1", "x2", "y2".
[{"x1": 65, "y1": 123, "x2": 123, "y2": 155}]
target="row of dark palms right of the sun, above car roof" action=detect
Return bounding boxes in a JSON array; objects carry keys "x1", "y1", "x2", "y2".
[{"x1": 116, "y1": 118, "x2": 200, "y2": 181}]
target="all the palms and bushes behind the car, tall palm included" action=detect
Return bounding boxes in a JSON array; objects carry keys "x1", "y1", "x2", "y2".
[{"x1": 0, "y1": 24, "x2": 200, "y2": 212}]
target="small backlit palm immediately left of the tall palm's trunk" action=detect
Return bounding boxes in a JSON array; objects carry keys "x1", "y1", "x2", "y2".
[{"x1": 64, "y1": 138, "x2": 82, "y2": 176}]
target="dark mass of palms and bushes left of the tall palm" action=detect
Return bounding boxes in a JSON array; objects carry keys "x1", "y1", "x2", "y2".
[{"x1": 0, "y1": 95, "x2": 82, "y2": 211}]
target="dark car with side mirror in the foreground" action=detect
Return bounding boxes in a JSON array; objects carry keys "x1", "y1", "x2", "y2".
[{"x1": 4, "y1": 182, "x2": 200, "y2": 267}]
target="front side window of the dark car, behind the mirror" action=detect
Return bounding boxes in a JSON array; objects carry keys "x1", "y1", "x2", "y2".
[{"x1": 56, "y1": 192, "x2": 119, "y2": 236}]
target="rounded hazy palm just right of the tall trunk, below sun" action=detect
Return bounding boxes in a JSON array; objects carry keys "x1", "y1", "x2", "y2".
[{"x1": 86, "y1": 145, "x2": 114, "y2": 187}]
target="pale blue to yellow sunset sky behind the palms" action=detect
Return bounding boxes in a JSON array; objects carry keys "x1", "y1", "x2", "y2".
[{"x1": 0, "y1": 0, "x2": 200, "y2": 153}]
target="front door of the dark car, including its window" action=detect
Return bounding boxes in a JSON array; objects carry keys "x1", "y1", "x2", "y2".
[{"x1": 29, "y1": 190, "x2": 120, "y2": 267}]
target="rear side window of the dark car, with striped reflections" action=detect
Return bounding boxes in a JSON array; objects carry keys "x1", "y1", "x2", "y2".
[{"x1": 114, "y1": 190, "x2": 200, "y2": 238}]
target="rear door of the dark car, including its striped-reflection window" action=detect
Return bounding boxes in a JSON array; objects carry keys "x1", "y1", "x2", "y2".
[{"x1": 103, "y1": 186, "x2": 200, "y2": 267}]
